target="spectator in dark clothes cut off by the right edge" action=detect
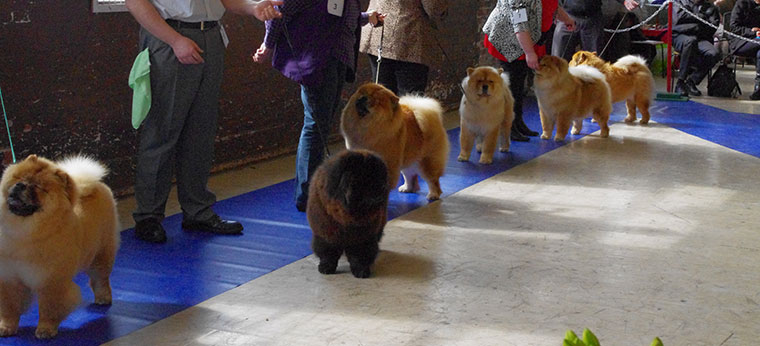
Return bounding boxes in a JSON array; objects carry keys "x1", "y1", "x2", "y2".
[{"x1": 729, "y1": 0, "x2": 760, "y2": 100}]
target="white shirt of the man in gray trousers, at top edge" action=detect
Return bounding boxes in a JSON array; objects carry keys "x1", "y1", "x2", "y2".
[{"x1": 151, "y1": 0, "x2": 225, "y2": 22}]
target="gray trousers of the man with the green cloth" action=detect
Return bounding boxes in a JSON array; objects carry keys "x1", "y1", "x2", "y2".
[{"x1": 133, "y1": 26, "x2": 224, "y2": 221}]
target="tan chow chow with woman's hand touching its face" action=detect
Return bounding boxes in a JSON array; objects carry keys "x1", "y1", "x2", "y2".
[{"x1": 533, "y1": 56, "x2": 612, "y2": 141}]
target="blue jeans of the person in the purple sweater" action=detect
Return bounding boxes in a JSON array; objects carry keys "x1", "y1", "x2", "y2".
[{"x1": 295, "y1": 58, "x2": 347, "y2": 211}]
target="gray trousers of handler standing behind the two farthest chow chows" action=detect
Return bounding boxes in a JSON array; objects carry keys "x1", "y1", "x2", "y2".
[{"x1": 552, "y1": 11, "x2": 604, "y2": 61}]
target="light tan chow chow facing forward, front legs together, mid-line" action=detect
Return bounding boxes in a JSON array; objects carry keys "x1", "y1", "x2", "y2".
[{"x1": 457, "y1": 66, "x2": 515, "y2": 164}]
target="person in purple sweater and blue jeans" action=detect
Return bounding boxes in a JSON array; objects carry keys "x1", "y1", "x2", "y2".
[{"x1": 253, "y1": 0, "x2": 385, "y2": 211}]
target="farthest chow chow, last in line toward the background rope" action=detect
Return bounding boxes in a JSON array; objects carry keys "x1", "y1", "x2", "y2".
[{"x1": 570, "y1": 51, "x2": 654, "y2": 124}]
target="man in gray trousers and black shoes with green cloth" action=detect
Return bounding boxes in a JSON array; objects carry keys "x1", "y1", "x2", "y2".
[{"x1": 126, "y1": 0, "x2": 282, "y2": 243}]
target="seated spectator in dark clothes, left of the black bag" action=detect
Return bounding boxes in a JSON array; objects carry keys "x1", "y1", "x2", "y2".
[{"x1": 673, "y1": 0, "x2": 720, "y2": 96}]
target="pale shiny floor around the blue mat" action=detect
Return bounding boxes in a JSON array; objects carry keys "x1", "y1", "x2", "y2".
[{"x1": 108, "y1": 73, "x2": 760, "y2": 346}]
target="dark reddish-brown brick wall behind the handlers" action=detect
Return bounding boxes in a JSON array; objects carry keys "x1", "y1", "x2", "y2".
[{"x1": 0, "y1": 0, "x2": 480, "y2": 194}]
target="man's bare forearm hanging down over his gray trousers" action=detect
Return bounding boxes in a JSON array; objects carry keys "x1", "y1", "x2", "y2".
[{"x1": 126, "y1": 0, "x2": 203, "y2": 64}]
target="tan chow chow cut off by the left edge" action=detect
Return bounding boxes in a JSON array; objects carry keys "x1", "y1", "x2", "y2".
[{"x1": 0, "y1": 155, "x2": 119, "y2": 339}]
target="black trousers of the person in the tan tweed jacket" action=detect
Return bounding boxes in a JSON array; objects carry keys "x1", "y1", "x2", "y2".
[{"x1": 367, "y1": 54, "x2": 429, "y2": 96}]
